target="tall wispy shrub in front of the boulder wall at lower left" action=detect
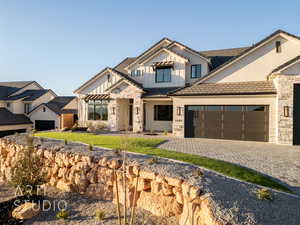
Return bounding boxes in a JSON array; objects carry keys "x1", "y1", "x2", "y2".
[{"x1": 11, "y1": 135, "x2": 46, "y2": 195}]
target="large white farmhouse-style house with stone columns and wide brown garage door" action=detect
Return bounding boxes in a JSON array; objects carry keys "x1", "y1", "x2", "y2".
[{"x1": 75, "y1": 30, "x2": 300, "y2": 144}]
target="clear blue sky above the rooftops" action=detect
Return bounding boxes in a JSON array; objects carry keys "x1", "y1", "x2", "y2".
[{"x1": 0, "y1": 0, "x2": 300, "y2": 95}]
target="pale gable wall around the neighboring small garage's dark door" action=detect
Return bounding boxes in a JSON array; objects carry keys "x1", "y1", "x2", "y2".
[{"x1": 29, "y1": 106, "x2": 60, "y2": 129}]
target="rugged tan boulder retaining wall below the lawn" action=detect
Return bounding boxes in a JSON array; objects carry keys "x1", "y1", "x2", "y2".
[{"x1": 0, "y1": 135, "x2": 224, "y2": 225}]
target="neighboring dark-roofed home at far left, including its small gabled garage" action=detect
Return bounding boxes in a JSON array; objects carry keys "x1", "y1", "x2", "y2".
[{"x1": 0, "y1": 81, "x2": 77, "y2": 137}]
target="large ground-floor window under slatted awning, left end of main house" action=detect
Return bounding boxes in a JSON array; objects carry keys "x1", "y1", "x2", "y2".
[{"x1": 88, "y1": 100, "x2": 108, "y2": 120}]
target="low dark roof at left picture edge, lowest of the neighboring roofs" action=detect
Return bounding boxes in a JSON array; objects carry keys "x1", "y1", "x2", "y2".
[{"x1": 0, "y1": 108, "x2": 32, "y2": 126}]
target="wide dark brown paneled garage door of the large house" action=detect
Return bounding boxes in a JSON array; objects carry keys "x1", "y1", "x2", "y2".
[{"x1": 185, "y1": 105, "x2": 269, "y2": 142}]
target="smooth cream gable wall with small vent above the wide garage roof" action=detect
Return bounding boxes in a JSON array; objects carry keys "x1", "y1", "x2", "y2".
[{"x1": 204, "y1": 37, "x2": 300, "y2": 83}]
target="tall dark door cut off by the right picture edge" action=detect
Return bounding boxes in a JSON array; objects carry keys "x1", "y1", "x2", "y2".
[{"x1": 293, "y1": 84, "x2": 300, "y2": 145}]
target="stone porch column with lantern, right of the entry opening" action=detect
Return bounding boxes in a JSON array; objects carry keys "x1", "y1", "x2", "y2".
[{"x1": 132, "y1": 95, "x2": 144, "y2": 133}]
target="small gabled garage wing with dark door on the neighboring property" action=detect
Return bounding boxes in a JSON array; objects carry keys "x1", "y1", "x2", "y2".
[{"x1": 28, "y1": 96, "x2": 77, "y2": 130}]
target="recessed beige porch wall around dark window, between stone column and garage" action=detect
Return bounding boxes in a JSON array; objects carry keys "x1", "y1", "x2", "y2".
[{"x1": 145, "y1": 100, "x2": 174, "y2": 131}]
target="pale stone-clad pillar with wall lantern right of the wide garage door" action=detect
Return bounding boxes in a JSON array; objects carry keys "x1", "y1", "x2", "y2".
[{"x1": 274, "y1": 75, "x2": 300, "y2": 145}]
